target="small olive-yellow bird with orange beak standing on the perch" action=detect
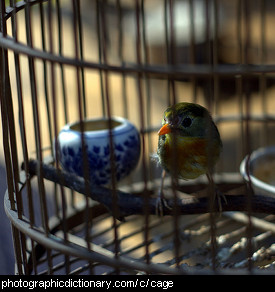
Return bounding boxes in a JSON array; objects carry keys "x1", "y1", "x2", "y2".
[{"x1": 157, "y1": 102, "x2": 225, "y2": 215}]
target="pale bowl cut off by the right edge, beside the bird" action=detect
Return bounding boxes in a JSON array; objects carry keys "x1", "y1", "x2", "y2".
[{"x1": 240, "y1": 146, "x2": 275, "y2": 197}]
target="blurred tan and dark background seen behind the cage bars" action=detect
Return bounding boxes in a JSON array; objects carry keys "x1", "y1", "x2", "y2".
[{"x1": 0, "y1": 0, "x2": 275, "y2": 274}]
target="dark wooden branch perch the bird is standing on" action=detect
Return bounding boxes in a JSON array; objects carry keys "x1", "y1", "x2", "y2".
[{"x1": 22, "y1": 160, "x2": 275, "y2": 219}]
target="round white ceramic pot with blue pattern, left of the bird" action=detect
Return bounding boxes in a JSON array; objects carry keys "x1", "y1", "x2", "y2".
[{"x1": 58, "y1": 117, "x2": 140, "y2": 185}]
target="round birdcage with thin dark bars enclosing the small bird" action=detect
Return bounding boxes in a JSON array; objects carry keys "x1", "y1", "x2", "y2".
[{"x1": 0, "y1": 0, "x2": 275, "y2": 274}]
